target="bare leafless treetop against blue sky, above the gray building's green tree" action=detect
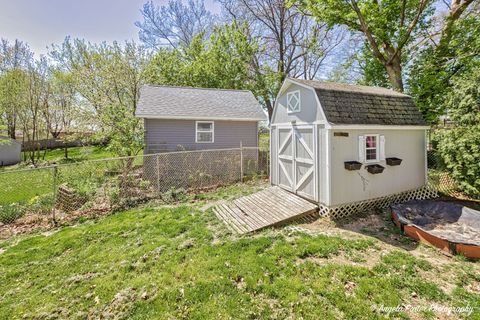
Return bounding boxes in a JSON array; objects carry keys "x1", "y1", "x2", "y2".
[{"x1": 135, "y1": 0, "x2": 214, "y2": 49}]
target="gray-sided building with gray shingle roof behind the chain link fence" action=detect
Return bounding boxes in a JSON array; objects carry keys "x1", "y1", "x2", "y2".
[{"x1": 136, "y1": 85, "x2": 267, "y2": 154}]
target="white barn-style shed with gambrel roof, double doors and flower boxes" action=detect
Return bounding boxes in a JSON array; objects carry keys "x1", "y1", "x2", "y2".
[{"x1": 270, "y1": 78, "x2": 429, "y2": 214}]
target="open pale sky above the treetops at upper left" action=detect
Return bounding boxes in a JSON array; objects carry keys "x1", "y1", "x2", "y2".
[{"x1": 0, "y1": 0, "x2": 219, "y2": 55}]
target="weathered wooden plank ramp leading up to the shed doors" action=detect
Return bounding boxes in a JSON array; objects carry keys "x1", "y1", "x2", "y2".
[{"x1": 213, "y1": 187, "x2": 318, "y2": 234}]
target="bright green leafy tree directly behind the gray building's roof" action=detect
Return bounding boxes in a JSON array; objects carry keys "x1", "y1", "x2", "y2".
[{"x1": 146, "y1": 22, "x2": 258, "y2": 92}]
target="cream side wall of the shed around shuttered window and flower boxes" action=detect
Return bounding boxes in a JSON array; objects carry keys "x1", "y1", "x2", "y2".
[{"x1": 328, "y1": 129, "x2": 425, "y2": 206}]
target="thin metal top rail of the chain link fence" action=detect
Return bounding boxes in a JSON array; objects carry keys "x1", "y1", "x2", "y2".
[{"x1": 0, "y1": 147, "x2": 261, "y2": 175}]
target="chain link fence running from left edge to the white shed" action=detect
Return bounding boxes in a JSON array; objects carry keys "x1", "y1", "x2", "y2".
[{"x1": 0, "y1": 147, "x2": 269, "y2": 237}]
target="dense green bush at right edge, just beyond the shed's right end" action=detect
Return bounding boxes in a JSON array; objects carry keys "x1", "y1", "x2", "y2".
[{"x1": 438, "y1": 125, "x2": 480, "y2": 198}]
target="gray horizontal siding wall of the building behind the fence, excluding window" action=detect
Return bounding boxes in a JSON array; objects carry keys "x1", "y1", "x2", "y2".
[{"x1": 145, "y1": 119, "x2": 258, "y2": 153}]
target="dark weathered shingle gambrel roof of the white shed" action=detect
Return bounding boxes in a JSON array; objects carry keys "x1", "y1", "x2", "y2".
[{"x1": 290, "y1": 79, "x2": 425, "y2": 126}]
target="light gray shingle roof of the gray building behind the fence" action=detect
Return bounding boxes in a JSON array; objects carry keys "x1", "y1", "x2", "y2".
[{"x1": 135, "y1": 85, "x2": 267, "y2": 121}]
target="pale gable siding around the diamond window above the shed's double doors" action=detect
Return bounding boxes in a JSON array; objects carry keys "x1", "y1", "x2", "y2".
[{"x1": 272, "y1": 84, "x2": 325, "y2": 124}]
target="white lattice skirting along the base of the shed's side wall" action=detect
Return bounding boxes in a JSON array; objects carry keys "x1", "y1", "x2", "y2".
[{"x1": 319, "y1": 186, "x2": 438, "y2": 219}]
